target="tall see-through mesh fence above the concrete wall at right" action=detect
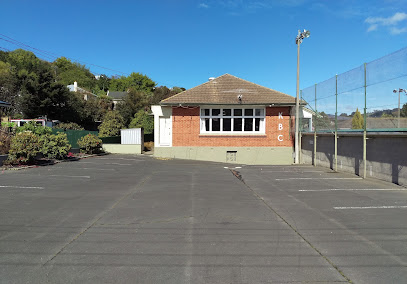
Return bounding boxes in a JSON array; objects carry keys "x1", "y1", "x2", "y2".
[{"x1": 301, "y1": 48, "x2": 407, "y2": 132}]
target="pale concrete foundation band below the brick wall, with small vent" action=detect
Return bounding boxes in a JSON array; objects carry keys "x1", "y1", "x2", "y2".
[{"x1": 154, "y1": 147, "x2": 294, "y2": 165}]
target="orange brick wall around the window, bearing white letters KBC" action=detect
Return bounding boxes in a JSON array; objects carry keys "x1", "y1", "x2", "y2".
[{"x1": 172, "y1": 107, "x2": 294, "y2": 147}]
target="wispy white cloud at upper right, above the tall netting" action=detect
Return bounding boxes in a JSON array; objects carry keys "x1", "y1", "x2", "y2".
[{"x1": 365, "y1": 12, "x2": 407, "y2": 35}]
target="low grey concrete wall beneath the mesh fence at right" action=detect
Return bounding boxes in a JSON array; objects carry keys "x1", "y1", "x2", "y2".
[{"x1": 301, "y1": 133, "x2": 407, "y2": 186}]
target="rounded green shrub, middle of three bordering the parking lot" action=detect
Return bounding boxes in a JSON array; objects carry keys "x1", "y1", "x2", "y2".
[{"x1": 40, "y1": 132, "x2": 71, "y2": 160}]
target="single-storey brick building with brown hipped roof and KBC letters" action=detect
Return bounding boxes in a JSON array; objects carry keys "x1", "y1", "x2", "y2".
[{"x1": 152, "y1": 74, "x2": 302, "y2": 165}]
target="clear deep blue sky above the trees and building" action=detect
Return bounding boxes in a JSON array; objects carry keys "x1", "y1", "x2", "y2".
[{"x1": 0, "y1": 0, "x2": 407, "y2": 96}]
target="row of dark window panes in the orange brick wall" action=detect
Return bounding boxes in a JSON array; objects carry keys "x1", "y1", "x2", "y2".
[{"x1": 201, "y1": 108, "x2": 265, "y2": 133}]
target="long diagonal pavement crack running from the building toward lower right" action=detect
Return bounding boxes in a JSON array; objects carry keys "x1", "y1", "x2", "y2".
[{"x1": 230, "y1": 170, "x2": 353, "y2": 283}]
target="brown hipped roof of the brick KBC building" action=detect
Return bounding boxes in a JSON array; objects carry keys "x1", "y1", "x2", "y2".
[{"x1": 160, "y1": 74, "x2": 295, "y2": 105}]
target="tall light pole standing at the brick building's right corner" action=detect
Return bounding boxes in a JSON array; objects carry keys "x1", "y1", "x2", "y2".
[{"x1": 294, "y1": 30, "x2": 310, "y2": 164}]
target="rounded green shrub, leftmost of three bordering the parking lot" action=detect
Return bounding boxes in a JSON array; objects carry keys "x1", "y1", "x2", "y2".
[{"x1": 8, "y1": 131, "x2": 42, "y2": 164}]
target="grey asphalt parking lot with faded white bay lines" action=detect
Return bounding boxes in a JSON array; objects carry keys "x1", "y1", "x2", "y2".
[{"x1": 0, "y1": 155, "x2": 407, "y2": 283}]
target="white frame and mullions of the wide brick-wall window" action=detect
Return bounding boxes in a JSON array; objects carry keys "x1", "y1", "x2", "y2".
[{"x1": 199, "y1": 106, "x2": 266, "y2": 135}]
